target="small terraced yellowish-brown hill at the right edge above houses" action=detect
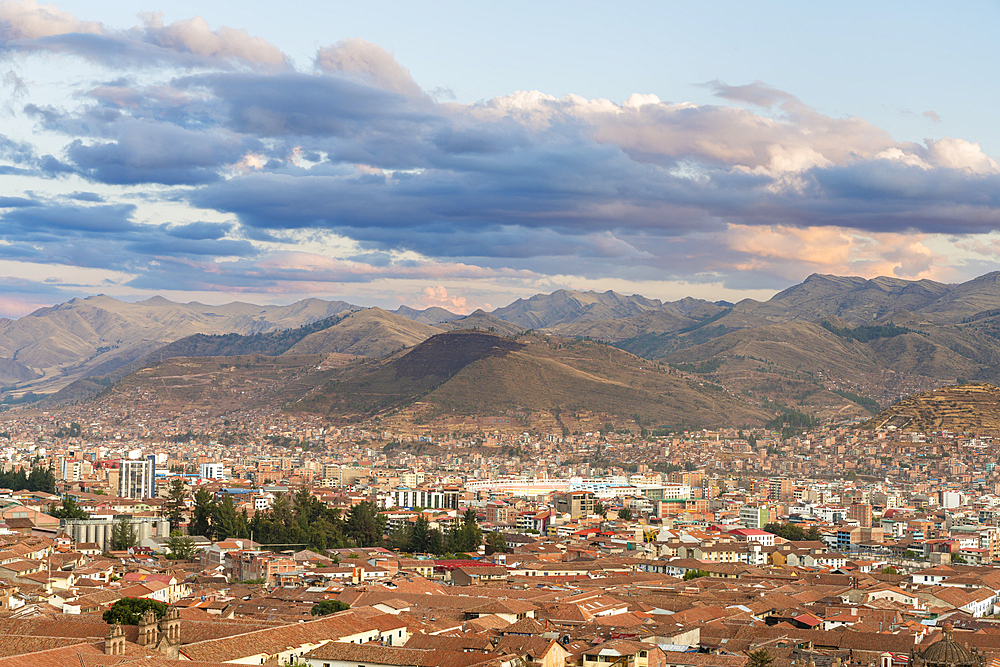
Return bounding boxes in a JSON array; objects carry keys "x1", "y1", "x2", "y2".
[{"x1": 865, "y1": 384, "x2": 1000, "y2": 436}]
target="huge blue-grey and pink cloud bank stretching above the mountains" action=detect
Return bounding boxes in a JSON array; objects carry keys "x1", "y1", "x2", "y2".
[{"x1": 0, "y1": 5, "x2": 1000, "y2": 308}]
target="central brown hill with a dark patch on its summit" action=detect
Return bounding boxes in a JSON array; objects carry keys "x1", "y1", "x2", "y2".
[{"x1": 296, "y1": 330, "x2": 767, "y2": 432}]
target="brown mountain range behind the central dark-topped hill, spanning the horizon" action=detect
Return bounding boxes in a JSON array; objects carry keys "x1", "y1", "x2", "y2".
[{"x1": 9, "y1": 273, "x2": 1000, "y2": 426}]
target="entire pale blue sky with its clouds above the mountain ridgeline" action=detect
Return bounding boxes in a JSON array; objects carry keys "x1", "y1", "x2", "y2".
[{"x1": 0, "y1": 0, "x2": 1000, "y2": 317}]
